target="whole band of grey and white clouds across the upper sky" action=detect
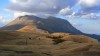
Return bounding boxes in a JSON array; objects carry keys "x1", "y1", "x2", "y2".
[{"x1": 7, "y1": 0, "x2": 100, "y2": 19}]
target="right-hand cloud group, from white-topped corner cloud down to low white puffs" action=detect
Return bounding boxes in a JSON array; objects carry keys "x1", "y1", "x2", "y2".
[{"x1": 66, "y1": 0, "x2": 100, "y2": 19}]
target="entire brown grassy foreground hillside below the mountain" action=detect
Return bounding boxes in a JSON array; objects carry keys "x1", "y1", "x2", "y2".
[{"x1": 0, "y1": 31, "x2": 100, "y2": 56}]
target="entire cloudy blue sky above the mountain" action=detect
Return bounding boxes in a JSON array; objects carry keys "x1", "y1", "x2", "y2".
[{"x1": 0, "y1": 0, "x2": 100, "y2": 35}]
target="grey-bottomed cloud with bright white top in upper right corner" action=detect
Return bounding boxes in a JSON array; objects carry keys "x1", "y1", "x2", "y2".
[{"x1": 78, "y1": 0, "x2": 100, "y2": 14}]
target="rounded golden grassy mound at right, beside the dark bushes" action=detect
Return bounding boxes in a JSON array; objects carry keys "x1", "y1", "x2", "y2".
[{"x1": 51, "y1": 33, "x2": 98, "y2": 43}]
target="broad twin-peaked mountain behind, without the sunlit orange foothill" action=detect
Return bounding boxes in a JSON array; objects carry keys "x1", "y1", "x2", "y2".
[{"x1": 1, "y1": 15, "x2": 82, "y2": 34}]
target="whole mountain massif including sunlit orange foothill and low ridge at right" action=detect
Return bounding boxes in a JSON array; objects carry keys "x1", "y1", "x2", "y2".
[{"x1": 0, "y1": 15, "x2": 100, "y2": 41}]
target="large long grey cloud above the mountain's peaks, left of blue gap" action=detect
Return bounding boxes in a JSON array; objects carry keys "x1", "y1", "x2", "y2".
[{"x1": 8, "y1": 0, "x2": 78, "y2": 14}]
